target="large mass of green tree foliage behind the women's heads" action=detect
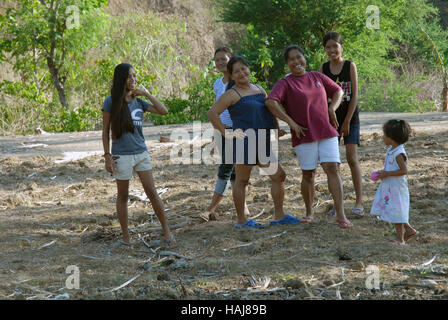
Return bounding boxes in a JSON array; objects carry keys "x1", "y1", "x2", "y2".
[{"x1": 218, "y1": 0, "x2": 446, "y2": 84}]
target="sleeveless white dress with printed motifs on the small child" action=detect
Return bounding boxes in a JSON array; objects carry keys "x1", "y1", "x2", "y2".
[{"x1": 370, "y1": 144, "x2": 409, "y2": 223}]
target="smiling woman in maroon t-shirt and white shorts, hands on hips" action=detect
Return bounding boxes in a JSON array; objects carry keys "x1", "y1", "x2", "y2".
[{"x1": 266, "y1": 46, "x2": 353, "y2": 229}]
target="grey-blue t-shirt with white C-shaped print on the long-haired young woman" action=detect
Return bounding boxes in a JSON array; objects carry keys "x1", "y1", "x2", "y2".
[{"x1": 101, "y1": 96, "x2": 151, "y2": 155}]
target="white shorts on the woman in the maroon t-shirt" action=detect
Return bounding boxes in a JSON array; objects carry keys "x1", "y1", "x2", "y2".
[{"x1": 294, "y1": 137, "x2": 341, "y2": 170}]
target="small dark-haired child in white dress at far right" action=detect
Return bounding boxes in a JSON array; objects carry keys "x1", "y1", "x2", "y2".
[{"x1": 370, "y1": 120, "x2": 418, "y2": 245}]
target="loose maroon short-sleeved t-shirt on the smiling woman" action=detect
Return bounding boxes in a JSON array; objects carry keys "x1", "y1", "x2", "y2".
[{"x1": 267, "y1": 71, "x2": 341, "y2": 147}]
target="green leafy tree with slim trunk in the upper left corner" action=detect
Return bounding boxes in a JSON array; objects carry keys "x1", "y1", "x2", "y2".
[{"x1": 0, "y1": 0, "x2": 108, "y2": 110}]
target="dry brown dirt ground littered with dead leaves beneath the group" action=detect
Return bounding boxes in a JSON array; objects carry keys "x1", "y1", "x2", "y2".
[{"x1": 0, "y1": 114, "x2": 448, "y2": 300}]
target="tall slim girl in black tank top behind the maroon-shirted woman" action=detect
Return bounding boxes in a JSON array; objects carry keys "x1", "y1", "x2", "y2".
[{"x1": 320, "y1": 32, "x2": 364, "y2": 216}]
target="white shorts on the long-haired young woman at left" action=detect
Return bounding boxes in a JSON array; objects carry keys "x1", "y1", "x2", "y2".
[{"x1": 112, "y1": 151, "x2": 152, "y2": 180}]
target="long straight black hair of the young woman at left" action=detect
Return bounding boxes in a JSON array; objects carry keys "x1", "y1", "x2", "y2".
[{"x1": 110, "y1": 63, "x2": 134, "y2": 140}]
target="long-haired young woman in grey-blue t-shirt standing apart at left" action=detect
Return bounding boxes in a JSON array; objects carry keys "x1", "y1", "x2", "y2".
[{"x1": 101, "y1": 63, "x2": 175, "y2": 246}]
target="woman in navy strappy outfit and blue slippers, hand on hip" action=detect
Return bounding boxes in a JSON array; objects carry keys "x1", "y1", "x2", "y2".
[{"x1": 207, "y1": 56, "x2": 300, "y2": 228}]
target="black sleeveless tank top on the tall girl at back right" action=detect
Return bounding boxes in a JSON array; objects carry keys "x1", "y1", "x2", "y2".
[{"x1": 322, "y1": 60, "x2": 359, "y2": 125}]
